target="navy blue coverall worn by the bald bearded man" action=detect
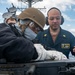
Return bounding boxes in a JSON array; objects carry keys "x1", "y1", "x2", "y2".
[{"x1": 35, "y1": 28, "x2": 75, "y2": 57}]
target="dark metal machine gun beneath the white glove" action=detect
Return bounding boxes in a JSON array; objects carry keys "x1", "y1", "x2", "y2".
[{"x1": 0, "y1": 60, "x2": 75, "y2": 75}]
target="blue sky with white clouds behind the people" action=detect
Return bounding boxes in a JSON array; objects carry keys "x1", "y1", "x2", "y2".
[{"x1": 0, "y1": 0, "x2": 75, "y2": 35}]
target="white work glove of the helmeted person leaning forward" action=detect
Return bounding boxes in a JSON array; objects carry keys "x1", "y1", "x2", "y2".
[{"x1": 34, "y1": 44, "x2": 67, "y2": 61}]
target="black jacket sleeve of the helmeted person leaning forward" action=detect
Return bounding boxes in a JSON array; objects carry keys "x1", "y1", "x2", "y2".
[{"x1": 0, "y1": 25, "x2": 37, "y2": 63}]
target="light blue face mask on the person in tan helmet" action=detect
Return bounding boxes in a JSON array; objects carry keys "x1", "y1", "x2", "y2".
[{"x1": 24, "y1": 27, "x2": 37, "y2": 40}]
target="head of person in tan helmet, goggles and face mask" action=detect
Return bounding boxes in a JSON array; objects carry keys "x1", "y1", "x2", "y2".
[{"x1": 15, "y1": 8, "x2": 46, "y2": 40}]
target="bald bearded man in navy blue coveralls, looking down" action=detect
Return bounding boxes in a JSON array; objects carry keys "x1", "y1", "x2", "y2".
[{"x1": 36, "y1": 7, "x2": 75, "y2": 58}]
